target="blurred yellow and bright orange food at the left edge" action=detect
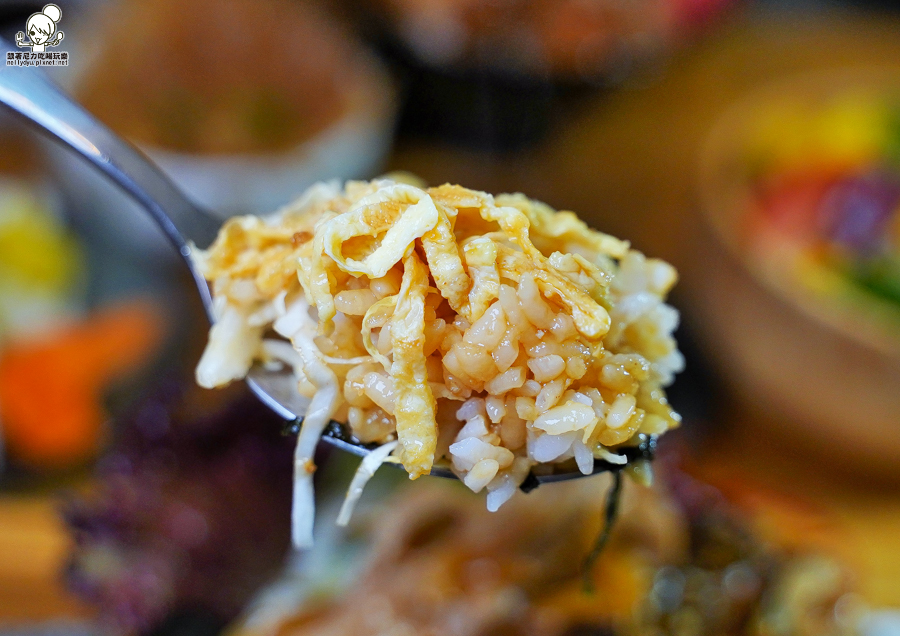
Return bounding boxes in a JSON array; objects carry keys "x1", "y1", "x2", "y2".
[{"x1": 0, "y1": 179, "x2": 164, "y2": 470}]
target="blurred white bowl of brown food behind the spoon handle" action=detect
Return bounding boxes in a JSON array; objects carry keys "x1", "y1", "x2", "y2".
[{"x1": 43, "y1": 0, "x2": 396, "y2": 255}]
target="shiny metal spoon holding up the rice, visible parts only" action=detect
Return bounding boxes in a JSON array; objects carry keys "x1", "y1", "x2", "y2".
[{"x1": 0, "y1": 44, "x2": 656, "y2": 482}]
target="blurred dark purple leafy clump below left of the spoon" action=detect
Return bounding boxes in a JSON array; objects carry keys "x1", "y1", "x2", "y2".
[{"x1": 63, "y1": 380, "x2": 291, "y2": 634}]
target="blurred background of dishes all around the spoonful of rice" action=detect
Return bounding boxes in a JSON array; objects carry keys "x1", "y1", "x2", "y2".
[{"x1": 0, "y1": 0, "x2": 900, "y2": 636}]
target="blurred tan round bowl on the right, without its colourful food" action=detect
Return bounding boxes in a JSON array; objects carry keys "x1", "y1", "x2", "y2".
[{"x1": 695, "y1": 68, "x2": 900, "y2": 478}]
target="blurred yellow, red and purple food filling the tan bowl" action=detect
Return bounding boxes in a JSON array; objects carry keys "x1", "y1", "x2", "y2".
[{"x1": 720, "y1": 82, "x2": 900, "y2": 350}]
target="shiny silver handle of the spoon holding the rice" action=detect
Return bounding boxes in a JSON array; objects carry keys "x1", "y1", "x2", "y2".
[{"x1": 0, "y1": 38, "x2": 219, "y2": 253}]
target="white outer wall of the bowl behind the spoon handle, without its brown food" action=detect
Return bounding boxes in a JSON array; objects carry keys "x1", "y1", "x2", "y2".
[{"x1": 45, "y1": 64, "x2": 396, "y2": 260}]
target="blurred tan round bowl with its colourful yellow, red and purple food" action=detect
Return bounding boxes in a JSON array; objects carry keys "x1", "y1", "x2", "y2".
[{"x1": 695, "y1": 68, "x2": 900, "y2": 475}]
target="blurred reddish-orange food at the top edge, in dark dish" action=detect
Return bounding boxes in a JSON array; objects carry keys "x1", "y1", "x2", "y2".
[{"x1": 361, "y1": 0, "x2": 732, "y2": 81}]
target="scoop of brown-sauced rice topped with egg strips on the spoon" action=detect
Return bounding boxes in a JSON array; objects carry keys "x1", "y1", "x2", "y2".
[{"x1": 196, "y1": 180, "x2": 682, "y2": 543}]
